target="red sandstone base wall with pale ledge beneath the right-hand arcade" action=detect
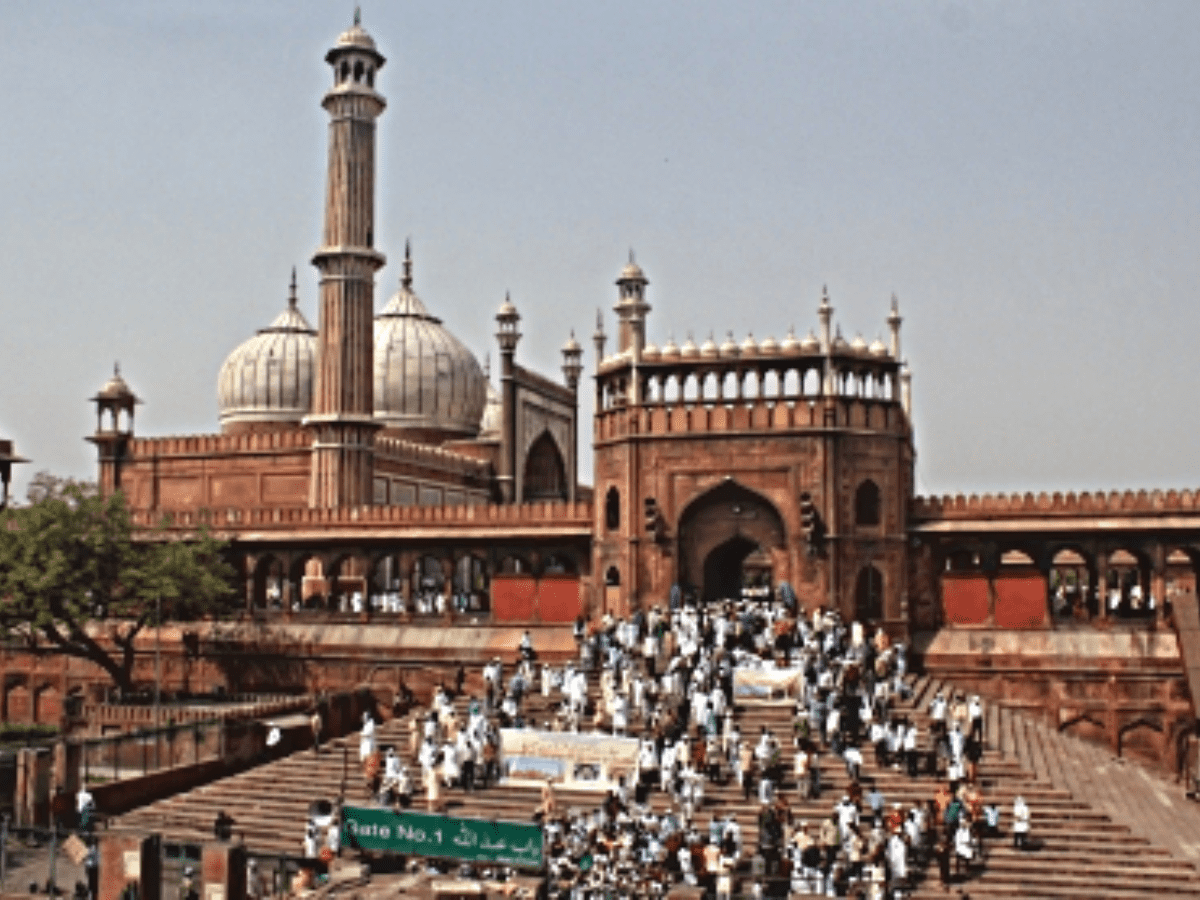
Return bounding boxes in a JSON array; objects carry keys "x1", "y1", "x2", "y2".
[{"x1": 913, "y1": 626, "x2": 1195, "y2": 774}]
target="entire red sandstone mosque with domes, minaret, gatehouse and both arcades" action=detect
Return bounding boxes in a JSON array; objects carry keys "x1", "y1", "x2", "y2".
[{"x1": 6, "y1": 14, "x2": 1200, "y2": 772}]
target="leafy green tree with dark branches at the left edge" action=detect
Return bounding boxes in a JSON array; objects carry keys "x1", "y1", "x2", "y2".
[{"x1": 0, "y1": 476, "x2": 235, "y2": 691}]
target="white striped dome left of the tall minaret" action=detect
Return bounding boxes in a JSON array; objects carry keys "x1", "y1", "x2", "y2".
[{"x1": 217, "y1": 274, "x2": 317, "y2": 430}]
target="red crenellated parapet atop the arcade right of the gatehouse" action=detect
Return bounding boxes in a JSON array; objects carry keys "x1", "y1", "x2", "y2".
[{"x1": 908, "y1": 490, "x2": 1200, "y2": 521}]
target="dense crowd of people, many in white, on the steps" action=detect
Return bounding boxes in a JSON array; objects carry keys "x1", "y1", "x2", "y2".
[{"x1": 343, "y1": 592, "x2": 1030, "y2": 900}]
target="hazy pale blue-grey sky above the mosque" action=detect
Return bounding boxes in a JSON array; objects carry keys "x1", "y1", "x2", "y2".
[{"x1": 0, "y1": 0, "x2": 1200, "y2": 496}]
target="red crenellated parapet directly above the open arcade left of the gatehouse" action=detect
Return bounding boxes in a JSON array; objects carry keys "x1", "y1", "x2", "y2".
[{"x1": 132, "y1": 503, "x2": 592, "y2": 533}]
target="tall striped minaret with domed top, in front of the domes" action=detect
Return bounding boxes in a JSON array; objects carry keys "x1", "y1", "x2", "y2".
[{"x1": 305, "y1": 10, "x2": 386, "y2": 506}]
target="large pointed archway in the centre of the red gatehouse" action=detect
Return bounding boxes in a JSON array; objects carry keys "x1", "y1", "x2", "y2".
[{"x1": 679, "y1": 479, "x2": 785, "y2": 600}]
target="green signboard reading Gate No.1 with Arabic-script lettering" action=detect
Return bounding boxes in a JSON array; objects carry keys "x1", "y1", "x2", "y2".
[{"x1": 342, "y1": 806, "x2": 542, "y2": 869}]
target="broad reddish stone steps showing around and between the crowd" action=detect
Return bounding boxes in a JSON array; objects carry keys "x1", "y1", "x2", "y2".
[{"x1": 115, "y1": 678, "x2": 1200, "y2": 900}]
